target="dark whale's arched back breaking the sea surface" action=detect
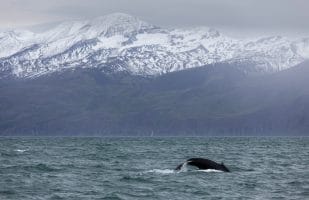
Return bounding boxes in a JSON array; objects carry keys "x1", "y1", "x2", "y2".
[{"x1": 175, "y1": 158, "x2": 230, "y2": 172}]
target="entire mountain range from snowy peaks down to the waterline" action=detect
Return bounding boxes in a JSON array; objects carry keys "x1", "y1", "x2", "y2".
[{"x1": 0, "y1": 13, "x2": 309, "y2": 136}]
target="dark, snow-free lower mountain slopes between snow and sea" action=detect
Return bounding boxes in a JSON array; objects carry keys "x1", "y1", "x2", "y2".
[{"x1": 0, "y1": 62, "x2": 309, "y2": 135}]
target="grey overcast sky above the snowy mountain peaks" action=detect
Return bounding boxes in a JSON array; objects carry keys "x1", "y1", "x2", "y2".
[{"x1": 0, "y1": 0, "x2": 309, "y2": 33}]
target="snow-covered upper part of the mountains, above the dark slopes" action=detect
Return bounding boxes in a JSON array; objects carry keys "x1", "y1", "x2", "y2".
[{"x1": 0, "y1": 13, "x2": 309, "y2": 77}]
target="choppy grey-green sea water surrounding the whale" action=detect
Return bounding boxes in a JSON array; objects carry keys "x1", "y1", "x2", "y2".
[{"x1": 0, "y1": 137, "x2": 309, "y2": 200}]
